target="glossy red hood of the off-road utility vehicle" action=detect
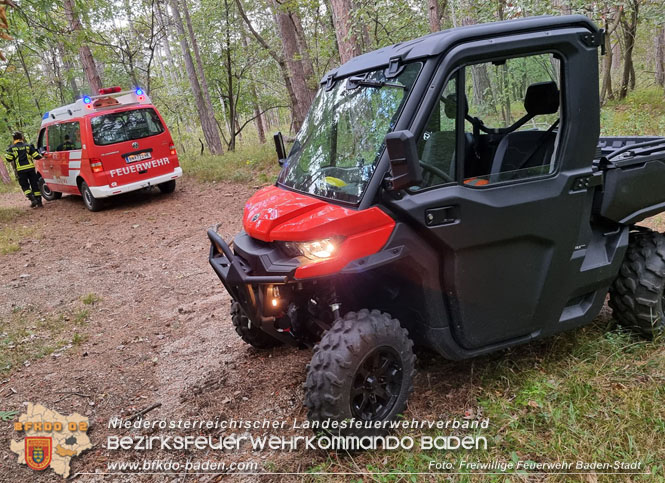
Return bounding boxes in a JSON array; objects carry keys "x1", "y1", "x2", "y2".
[{"x1": 242, "y1": 186, "x2": 395, "y2": 279}]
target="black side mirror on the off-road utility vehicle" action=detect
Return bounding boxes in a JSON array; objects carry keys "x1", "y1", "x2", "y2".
[{"x1": 386, "y1": 131, "x2": 423, "y2": 191}]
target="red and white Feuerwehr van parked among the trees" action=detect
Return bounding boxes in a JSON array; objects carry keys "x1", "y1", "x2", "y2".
[{"x1": 35, "y1": 87, "x2": 182, "y2": 211}]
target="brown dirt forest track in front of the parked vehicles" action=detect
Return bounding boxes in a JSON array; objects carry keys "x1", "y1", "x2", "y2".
[{"x1": 0, "y1": 179, "x2": 592, "y2": 481}]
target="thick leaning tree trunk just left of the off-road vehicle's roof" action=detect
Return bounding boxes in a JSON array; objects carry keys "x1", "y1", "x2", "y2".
[{"x1": 273, "y1": 0, "x2": 314, "y2": 129}]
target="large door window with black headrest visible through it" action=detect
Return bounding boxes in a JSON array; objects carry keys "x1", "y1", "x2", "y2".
[{"x1": 464, "y1": 54, "x2": 561, "y2": 187}]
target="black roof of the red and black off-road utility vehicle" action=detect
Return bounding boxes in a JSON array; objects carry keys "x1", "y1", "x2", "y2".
[{"x1": 321, "y1": 15, "x2": 598, "y2": 84}]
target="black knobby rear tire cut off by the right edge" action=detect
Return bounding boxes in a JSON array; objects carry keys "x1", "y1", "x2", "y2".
[{"x1": 609, "y1": 231, "x2": 665, "y2": 337}]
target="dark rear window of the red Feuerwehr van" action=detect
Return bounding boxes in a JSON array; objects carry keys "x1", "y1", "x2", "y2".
[{"x1": 90, "y1": 109, "x2": 164, "y2": 146}]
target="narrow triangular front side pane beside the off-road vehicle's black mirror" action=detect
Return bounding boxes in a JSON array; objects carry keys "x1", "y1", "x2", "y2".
[{"x1": 412, "y1": 76, "x2": 457, "y2": 191}]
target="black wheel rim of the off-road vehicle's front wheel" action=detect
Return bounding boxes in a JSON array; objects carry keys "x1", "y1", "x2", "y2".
[{"x1": 351, "y1": 347, "x2": 403, "y2": 421}]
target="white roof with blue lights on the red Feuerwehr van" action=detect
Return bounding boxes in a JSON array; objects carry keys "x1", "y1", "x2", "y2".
[{"x1": 42, "y1": 87, "x2": 151, "y2": 127}]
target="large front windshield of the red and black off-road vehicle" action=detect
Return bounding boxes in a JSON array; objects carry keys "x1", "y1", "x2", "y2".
[{"x1": 278, "y1": 63, "x2": 421, "y2": 203}]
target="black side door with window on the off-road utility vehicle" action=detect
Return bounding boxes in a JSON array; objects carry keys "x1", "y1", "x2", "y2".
[{"x1": 384, "y1": 29, "x2": 598, "y2": 350}]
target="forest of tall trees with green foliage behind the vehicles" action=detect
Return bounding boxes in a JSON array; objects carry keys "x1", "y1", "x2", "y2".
[{"x1": 0, "y1": 0, "x2": 665, "y2": 164}]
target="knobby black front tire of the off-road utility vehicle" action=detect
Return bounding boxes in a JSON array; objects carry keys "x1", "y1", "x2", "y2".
[{"x1": 305, "y1": 309, "x2": 416, "y2": 436}]
